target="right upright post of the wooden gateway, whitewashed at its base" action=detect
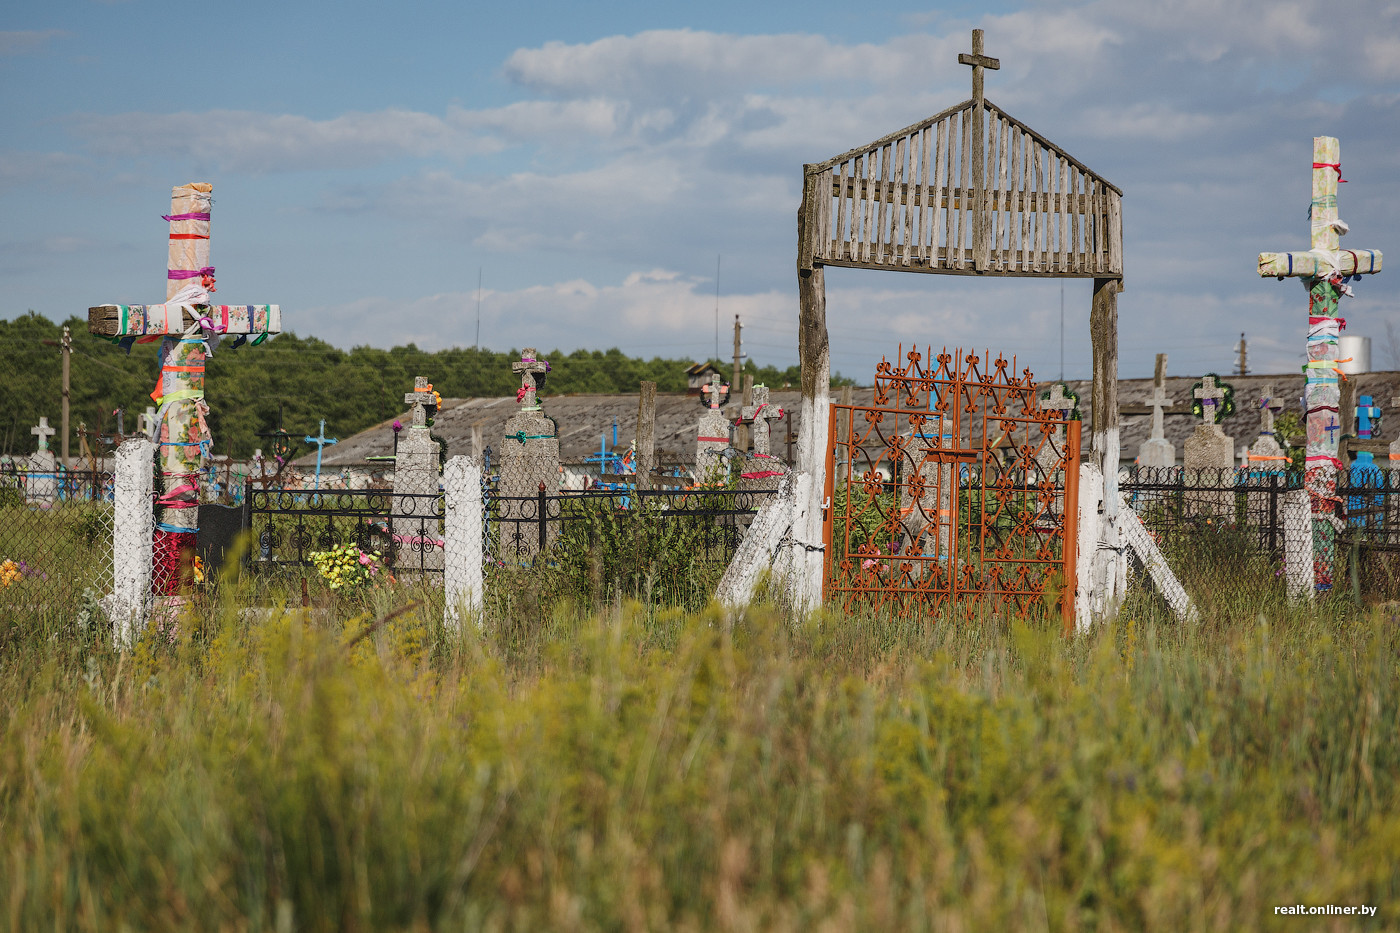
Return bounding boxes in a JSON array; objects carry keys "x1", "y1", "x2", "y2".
[{"x1": 1085, "y1": 279, "x2": 1127, "y2": 614}]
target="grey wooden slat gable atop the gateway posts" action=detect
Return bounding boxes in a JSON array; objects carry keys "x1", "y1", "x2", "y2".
[{"x1": 806, "y1": 101, "x2": 1123, "y2": 277}]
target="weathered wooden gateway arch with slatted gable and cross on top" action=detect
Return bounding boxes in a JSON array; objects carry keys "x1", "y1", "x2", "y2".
[{"x1": 795, "y1": 29, "x2": 1126, "y2": 626}]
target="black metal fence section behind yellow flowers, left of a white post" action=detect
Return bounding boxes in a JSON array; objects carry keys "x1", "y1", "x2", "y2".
[{"x1": 244, "y1": 489, "x2": 444, "y2": 574}]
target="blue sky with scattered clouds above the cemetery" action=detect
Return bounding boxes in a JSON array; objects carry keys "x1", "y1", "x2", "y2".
[{"x1": 0, "y1": 0, "x2": 1400, "y2": 384}]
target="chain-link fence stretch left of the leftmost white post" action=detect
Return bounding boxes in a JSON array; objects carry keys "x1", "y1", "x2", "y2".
[{"x1": 0, "y1": 471, "x2": 113, "y2": 625}]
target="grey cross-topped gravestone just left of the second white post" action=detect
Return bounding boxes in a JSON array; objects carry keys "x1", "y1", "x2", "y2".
[{"x1": 389, "y1": 375, "x2": 442, "y2": 573}]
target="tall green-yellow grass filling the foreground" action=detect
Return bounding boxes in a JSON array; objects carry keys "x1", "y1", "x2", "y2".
[{"x1": 0, "y1": 554, "x2": 1400, "y2": 932}]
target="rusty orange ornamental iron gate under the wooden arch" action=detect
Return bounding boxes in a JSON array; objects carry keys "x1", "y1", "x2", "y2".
[{"x1": 823, "y1": 346, "x2": 1079, "y2": 630}]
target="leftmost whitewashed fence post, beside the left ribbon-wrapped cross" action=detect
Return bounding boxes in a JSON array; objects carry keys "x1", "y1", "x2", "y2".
[{"x1": 108, "y1": 437, "x2": 155, "y2": 647}]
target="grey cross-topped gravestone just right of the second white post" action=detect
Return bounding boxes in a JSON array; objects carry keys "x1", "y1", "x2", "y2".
[{"x1": 497, "y1": 347, "x2": 559, "y2": 560}]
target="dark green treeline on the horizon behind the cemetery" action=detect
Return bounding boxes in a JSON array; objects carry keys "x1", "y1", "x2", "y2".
[{"x1": 0, "y1": 311, "x2": 841, "y2": 457}]
